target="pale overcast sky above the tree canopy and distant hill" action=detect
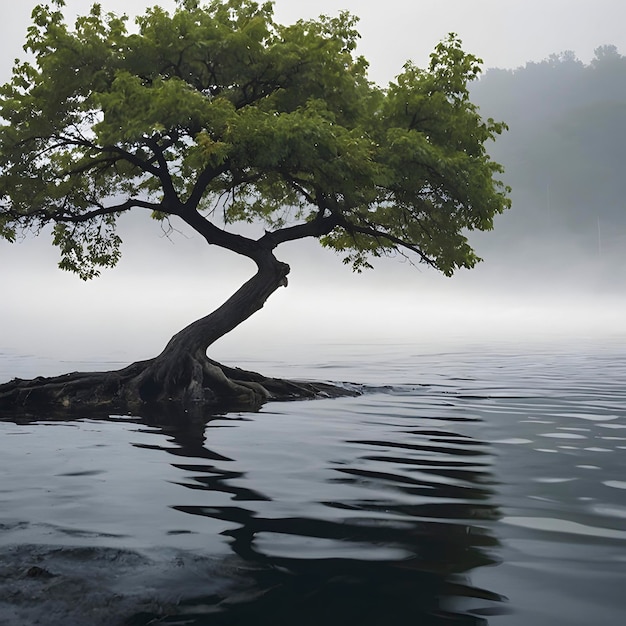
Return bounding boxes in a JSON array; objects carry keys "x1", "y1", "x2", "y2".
[{"x1": 0, "y1": 0, "x2": 626, "y2": 83}]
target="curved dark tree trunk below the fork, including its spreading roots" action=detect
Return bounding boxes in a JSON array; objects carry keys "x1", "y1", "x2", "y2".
[{"x1": 0, "y1": 251, "x2": 351, "y2": 414}]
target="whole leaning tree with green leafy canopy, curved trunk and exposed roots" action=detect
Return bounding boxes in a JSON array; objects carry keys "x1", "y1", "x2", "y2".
[{"x1": 0, "y1": 0, "x2": 508, "y2": 408}]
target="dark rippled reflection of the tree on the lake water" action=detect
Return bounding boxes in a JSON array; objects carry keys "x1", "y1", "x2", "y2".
[{"x1": 133, "y1": 403, "x2": 504, "y2": 625}]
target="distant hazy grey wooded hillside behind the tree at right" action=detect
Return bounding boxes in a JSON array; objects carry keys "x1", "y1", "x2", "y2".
[{"x1": 472, "y1": 46, "x2": 626, "y2": 261}]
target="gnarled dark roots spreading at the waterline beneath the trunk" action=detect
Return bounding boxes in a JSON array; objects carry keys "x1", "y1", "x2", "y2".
[{"x1": 0, "y1": 354, "x2": 356, "y2": 416}]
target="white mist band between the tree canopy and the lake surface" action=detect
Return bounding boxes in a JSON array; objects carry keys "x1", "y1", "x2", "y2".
[{"x1": 0, "y1": 202, "x2": 626, "y2": 374}]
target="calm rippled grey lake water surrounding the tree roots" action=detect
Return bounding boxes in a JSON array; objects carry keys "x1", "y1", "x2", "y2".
[{"x1": 0, "y1": 337, "x2": 626, "y2": 626}]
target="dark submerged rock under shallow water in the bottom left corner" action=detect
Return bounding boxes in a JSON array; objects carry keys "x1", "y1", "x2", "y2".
[{"x1": 0, "y1": 545, "x2": 254, "y2": 626}]
